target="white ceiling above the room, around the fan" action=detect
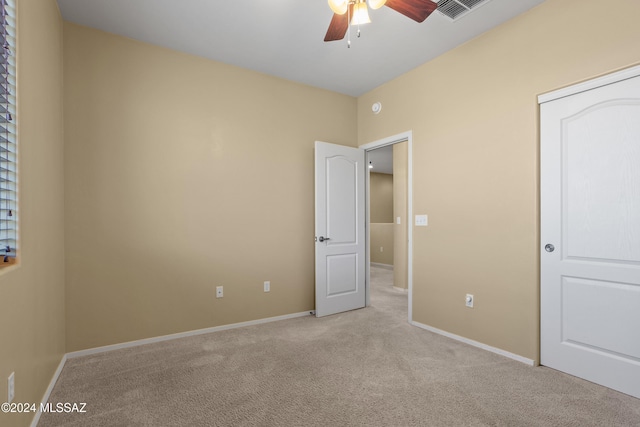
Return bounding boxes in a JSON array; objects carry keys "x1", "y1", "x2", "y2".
[{"x1": 58, "y1": 0, "x2": 544, "y2": 96}]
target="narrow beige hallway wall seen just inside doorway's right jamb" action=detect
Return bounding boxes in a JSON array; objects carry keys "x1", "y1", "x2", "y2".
[{"x1": 393, "y1": 141, "x2": 409, "y2": 289}]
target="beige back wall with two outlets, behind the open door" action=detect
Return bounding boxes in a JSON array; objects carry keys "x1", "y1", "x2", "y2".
[{"x1": 64, "y1": 23, "x2": 357, "y2": 351}]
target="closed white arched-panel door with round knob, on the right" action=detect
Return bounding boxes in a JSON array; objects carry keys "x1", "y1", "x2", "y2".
[{"x1": 540, "y1": 70, "x2": 640, "y2": 397}]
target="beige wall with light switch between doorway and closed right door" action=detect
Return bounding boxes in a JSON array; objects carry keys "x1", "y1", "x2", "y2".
[{"x1": 358, "y1": 0, "x2": 640, "y2": 360}]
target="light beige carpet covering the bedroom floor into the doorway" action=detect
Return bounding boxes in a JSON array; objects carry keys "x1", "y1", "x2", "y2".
[{"x1": 39, "y1": 268, "x2": 640, "y2": 427}]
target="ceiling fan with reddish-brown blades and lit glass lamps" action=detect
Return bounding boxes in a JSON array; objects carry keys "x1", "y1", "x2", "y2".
[{"x1": 324, "y1": 0, "x2": 438, "y2": 42}]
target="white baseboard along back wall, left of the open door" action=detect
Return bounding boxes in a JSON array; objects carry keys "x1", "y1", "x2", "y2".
[{"x1": 66, "y1": 310, "x2": 314, "y2": 359}]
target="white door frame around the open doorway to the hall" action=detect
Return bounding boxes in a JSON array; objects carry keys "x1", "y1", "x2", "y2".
[{"x1": 359, "y1": 131, "x2": 413, "y2": 323}]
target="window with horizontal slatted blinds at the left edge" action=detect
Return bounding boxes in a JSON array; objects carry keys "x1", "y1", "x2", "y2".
[{"x1": 0, "y1": 0, "x2": 18, "y2": 268}]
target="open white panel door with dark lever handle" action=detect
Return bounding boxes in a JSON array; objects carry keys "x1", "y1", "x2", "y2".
[{"x1": 315, "y1": 142, "x2": 366, "y2": 317}]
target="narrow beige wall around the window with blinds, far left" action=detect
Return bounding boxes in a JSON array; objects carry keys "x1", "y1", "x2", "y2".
[{"x1": 0, "y1": 0, "x2": 65, "y2": 426}]
